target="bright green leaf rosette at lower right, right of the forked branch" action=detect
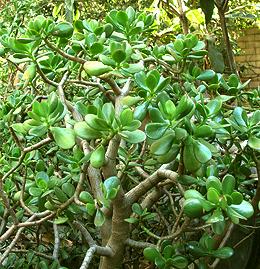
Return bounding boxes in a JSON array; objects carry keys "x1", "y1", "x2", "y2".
[{"x1": 184, "y1": 175, "x2": 254, "y2": 229}]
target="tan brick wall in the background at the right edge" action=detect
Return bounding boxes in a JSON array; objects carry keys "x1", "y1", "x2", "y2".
[{"x1": 236, "y1": 26, "x2": 260, "y2": 88}]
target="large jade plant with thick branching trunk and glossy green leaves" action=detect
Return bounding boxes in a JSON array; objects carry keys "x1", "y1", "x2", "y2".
[{"x1": 0, "y1": 2, "x2": 260, "y2": 269}]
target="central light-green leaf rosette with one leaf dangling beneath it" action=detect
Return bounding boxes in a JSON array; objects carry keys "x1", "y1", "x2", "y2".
[{"x1": 74, "y1": 100, "x2": 146, "y2": 165}]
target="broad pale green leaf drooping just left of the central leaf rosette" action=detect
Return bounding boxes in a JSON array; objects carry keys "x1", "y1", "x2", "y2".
[{"x1": 50, "y1": 127, "x2": 75, "y2": 149}]
